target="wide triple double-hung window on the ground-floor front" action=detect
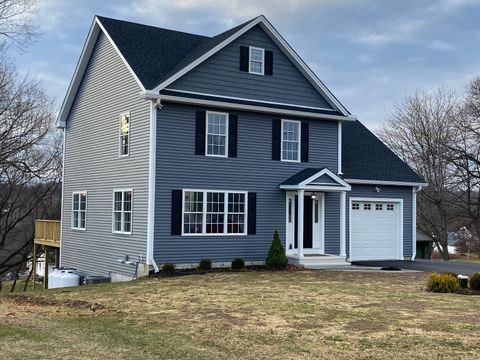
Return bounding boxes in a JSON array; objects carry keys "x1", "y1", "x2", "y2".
[{"x1": 183, "y1": 190, "x2": 247, "y2": 235}]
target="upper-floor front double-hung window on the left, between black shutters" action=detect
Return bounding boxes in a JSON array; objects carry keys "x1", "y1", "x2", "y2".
[{"x1": 206, "y1": 111, "x2": 228, "y2": 157}]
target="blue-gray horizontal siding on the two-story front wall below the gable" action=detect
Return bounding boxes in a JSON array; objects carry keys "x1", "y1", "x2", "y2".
[{"x1": 154, "y1": 103, "x2": 340, "y2": 264}]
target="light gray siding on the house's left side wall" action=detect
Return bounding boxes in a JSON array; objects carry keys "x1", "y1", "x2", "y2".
[{"x1": 61, "y1": 33, "x2": 150, "y2": 275}]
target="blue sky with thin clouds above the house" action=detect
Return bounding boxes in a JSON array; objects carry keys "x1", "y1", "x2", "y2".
[{"x1": 14, "y1": 0, "x2": 480, "y2": 129}]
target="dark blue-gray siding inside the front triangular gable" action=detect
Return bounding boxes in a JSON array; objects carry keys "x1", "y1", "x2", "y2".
[{"x1": 168, "y1": 26, "x2": 331, "y2": 109}]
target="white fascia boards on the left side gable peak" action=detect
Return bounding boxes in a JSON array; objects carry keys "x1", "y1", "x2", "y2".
[{"x1": 57, "y1": 16, "x2": 145, "y2": 128}]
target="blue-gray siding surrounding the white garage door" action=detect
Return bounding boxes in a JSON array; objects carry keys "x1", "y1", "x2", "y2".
[{"x1": 346, "y1": 185, "x2": 412, "y2": 256}]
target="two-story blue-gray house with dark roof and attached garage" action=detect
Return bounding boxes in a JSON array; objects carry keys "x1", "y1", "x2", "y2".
[{"x1": 58, "y1": 16, "x2": 426, "y2": 280}]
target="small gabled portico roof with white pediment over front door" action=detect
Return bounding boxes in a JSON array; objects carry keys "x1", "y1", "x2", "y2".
[{"x1": 280, "y1": 168, "x2": 351, "y2": 191}]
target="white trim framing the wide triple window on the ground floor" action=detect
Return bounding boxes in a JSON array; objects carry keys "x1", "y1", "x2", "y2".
[{"x1": 182, "y1": 189, "x2": 248, "y2": 236}]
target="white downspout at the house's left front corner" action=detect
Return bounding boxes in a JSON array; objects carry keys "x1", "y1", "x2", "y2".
[{"x1": 147, "y1": 97, "x2": 161, "y2": 273}]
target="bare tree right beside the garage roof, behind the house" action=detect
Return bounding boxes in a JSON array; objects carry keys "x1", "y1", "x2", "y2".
[{"x1": 379, "y1": 88, "x2": 460, "y2": 260}]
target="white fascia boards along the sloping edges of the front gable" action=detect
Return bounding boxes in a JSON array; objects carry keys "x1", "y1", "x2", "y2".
[{"x1": 153, "y1": 15, "x2": 354, "y2": 118}]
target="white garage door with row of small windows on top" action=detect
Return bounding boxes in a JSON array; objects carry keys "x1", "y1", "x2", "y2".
[{"x1": 350, "y1": 199, "x2": 402, "y2": 261}]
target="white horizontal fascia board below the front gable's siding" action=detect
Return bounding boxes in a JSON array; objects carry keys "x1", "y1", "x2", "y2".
[{"x1": 158, "y1": 93, "x2": 355, "y2": 121}]
